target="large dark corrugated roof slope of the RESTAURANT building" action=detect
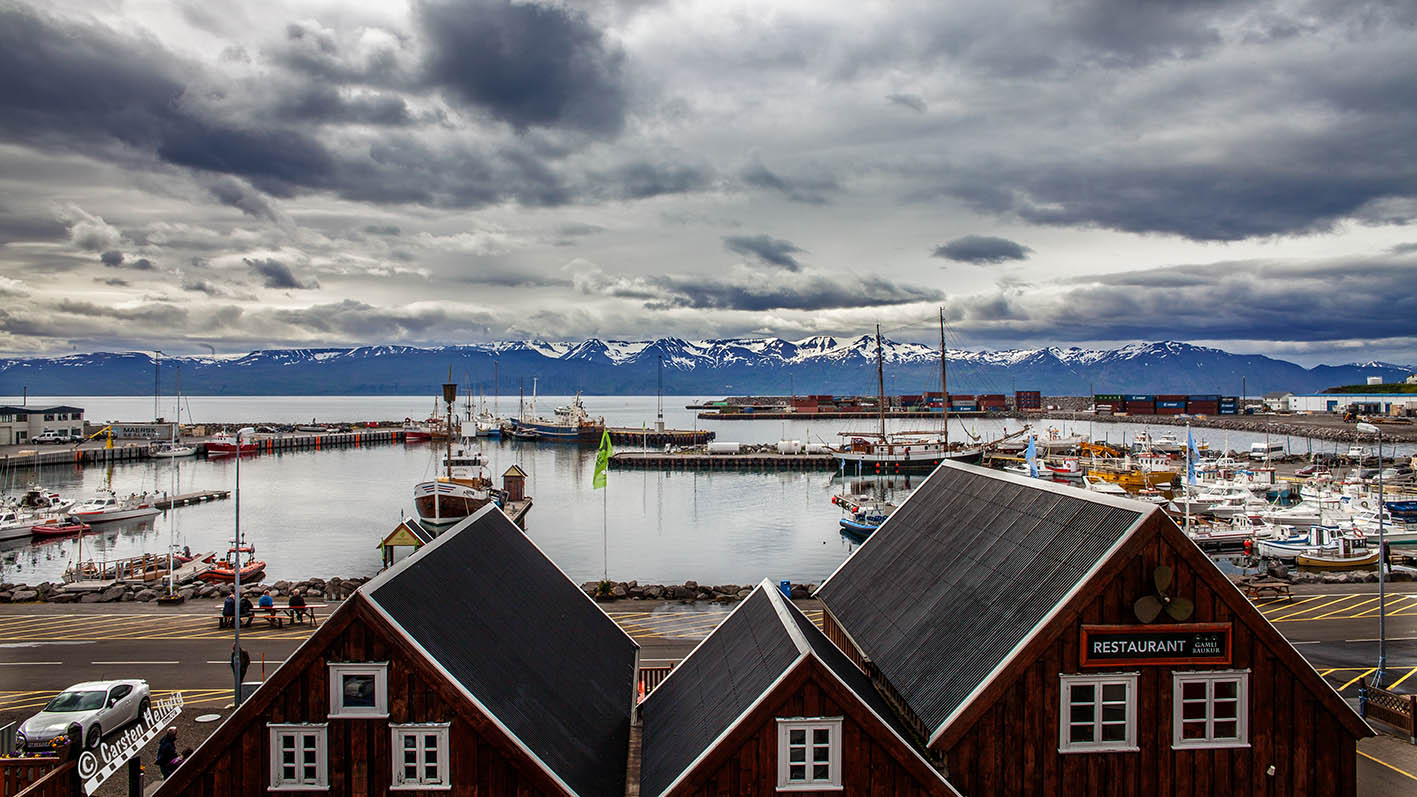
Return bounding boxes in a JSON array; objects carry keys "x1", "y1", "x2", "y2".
[{"x1": 816, "y1": 462, "x2": 1148, "y2": 730}]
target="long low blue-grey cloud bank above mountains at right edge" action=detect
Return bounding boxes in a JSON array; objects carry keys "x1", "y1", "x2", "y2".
[{"x1": 969, "y1": 258, "x2": 1417, "y2": 342}]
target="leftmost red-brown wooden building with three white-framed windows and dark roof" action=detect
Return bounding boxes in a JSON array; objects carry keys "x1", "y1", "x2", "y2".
[{"x1": 157, "y1": 506, "x2": 639, "y2": 797}]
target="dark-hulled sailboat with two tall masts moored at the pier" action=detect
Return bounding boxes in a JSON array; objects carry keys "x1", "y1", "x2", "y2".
[{"x1": 833, "y1": 309, "x2": 1008, "y2": 474}]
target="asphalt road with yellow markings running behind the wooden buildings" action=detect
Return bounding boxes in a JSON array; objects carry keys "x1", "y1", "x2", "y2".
[{"x1": 0, "y1": 592, "x2": 1417, "y2": 794}]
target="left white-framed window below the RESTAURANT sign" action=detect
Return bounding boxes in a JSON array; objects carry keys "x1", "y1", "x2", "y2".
[{"x1": 1058, "y1": 672, "x2": 1136, "y2": 753}]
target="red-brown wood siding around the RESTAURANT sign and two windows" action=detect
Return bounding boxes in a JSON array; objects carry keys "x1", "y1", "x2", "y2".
[{"x1": 937, "y1": 519, "x2": 1356, "y2": 797}]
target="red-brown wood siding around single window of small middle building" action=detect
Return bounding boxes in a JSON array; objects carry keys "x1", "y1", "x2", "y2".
[{"x1": 673, "y1": 658, "x2": 949, "y2": 797}]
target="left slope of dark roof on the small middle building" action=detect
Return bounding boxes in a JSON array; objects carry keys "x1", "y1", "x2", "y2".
[{"x1": 639, "y1": 589, "x2": 801, "y2": 796}]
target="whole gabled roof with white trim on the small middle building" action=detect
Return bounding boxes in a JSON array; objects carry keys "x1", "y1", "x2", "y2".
[{"x1": 639, "y1": 580, "x2": 948, "y2": 796}]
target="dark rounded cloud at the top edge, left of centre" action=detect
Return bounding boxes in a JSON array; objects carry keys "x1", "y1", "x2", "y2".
[{"x1": 414, "y1": 0, "x2": 628, "y2": 135}]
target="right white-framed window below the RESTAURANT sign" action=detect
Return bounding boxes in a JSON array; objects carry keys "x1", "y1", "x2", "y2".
[{"x1": 1170, "y1": 669, "x2": 1250, "y2": 747}]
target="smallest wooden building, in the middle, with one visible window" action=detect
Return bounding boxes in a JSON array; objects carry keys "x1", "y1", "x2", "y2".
[{"x1": 639, "y1": 581, "x2": 956, "y2": 797}]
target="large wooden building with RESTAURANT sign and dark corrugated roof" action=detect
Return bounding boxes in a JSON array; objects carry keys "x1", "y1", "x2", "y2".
[{"x1": 818, "y1": 462, "x2": 1370, "y2": 796}]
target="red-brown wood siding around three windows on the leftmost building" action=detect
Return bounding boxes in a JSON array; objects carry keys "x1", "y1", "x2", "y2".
[{"x1": 162, "y1": 597, "x2": 564, "y2": 797}]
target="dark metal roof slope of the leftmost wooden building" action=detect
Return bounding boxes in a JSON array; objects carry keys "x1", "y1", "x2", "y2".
[{"x1": 366, "y1": 508, "x2": 638, "y2": 796}]
